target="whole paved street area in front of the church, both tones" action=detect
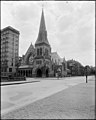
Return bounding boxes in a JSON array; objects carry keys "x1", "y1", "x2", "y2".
[{"x1": 1, "y1": 77, "x2": 95, "y2": 119}]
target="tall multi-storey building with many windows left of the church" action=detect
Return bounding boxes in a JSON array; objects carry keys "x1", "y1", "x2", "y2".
[{"x1": 1, "y1": 26, "x2": 20, "y2": 76}]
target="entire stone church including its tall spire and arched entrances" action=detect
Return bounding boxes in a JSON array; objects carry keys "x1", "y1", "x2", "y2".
[{"x1": 18, "y1": 10, "x2": 67, "y2": 77}]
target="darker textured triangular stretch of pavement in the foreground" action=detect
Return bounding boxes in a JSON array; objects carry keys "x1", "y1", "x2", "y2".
[{"x1": 1, "y1": 80, "x2": 95, "y2": 119}]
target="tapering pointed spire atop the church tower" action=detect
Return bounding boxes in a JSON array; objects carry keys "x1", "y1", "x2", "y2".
[{"x1": 35, "y1": 9, "x2": 50, "y2": 46}]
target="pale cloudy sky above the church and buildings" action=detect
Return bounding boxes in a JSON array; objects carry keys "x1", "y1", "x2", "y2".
[{"x1": 1, "y1": 1, "x2": 95, "y2": 66}]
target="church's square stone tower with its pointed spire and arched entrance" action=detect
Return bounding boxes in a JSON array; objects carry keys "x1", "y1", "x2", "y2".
[{"x1": 35, "y1": 9, "x2": 51, "y2": 77}]
